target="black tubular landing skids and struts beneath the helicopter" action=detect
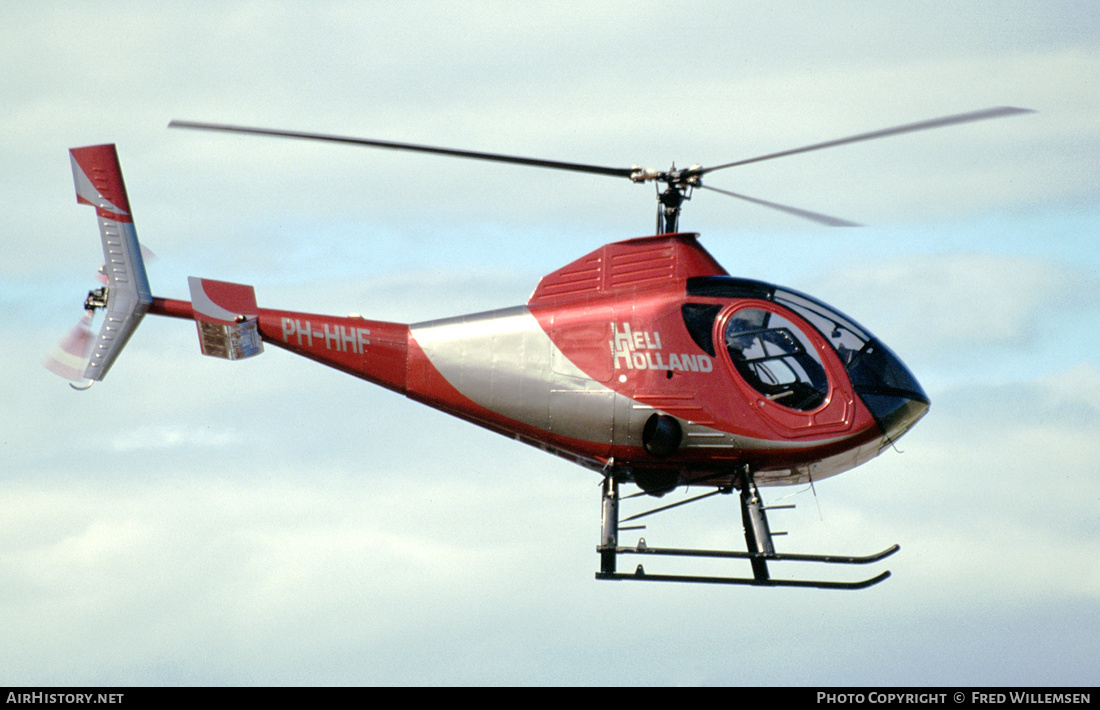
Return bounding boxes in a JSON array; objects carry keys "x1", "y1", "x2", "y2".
[{"x1": 596, "y1": 469, "x2": 901, "y2": 589}]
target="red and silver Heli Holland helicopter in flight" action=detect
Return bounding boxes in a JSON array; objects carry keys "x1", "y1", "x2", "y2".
[{"x1": 47, "y1": 107, "x2": 1029, "y2": 589}]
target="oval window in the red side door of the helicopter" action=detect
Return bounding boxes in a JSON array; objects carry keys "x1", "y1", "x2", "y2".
[{"x1": 725, "y1": 308, "x2": 828, "y2": 412}]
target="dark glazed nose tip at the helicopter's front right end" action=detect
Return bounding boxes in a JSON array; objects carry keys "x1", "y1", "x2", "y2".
[{"x1": 848, "y1": 339, "x2": 930, "y2": 441}]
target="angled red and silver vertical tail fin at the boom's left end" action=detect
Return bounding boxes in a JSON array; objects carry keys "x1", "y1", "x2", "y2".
[{"x1": 69, "y1": 144, "x2": 153, "y2": 380}]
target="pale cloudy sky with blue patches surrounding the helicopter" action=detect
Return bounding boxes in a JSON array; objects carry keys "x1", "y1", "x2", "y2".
[{"x1": 0, "y1": 0, "x2": 1100, "y2": 687}]
